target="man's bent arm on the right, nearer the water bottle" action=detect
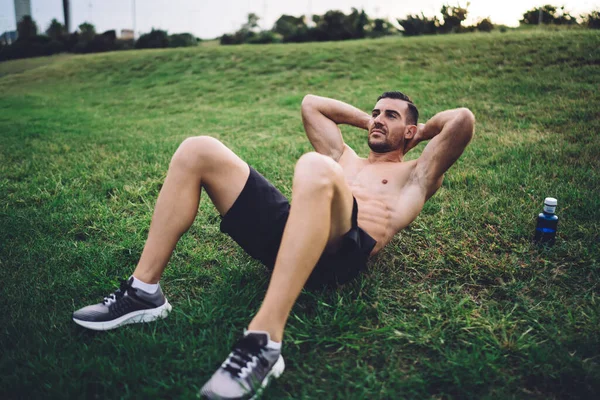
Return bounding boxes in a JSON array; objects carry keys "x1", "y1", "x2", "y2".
[{"x1": 406, "y1": 108, "x2": 475, "y2": 198}]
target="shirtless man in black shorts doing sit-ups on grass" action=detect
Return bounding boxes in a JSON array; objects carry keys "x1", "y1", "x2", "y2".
[{"x1": 73, "y1": 92, "x2": 474, "y2": 399}]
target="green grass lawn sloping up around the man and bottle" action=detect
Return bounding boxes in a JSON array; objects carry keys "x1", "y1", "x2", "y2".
[{"x1": 0, "y1": 31, "x2": 600, "y2": 399}]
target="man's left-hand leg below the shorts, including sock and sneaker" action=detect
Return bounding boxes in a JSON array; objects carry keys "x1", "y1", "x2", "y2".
[{"x1": 73, "y1": 136, "x2": 250, "y2": 330}]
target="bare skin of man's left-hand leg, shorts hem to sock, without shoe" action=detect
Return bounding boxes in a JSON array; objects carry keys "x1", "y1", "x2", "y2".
[{"x1": 133, "y1": 136, "x2": 250, "y2": 283}]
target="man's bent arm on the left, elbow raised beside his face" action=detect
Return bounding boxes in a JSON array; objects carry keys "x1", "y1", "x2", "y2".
[{"x1": 302, "y1": 94, "x2": 370, "y2": 161}]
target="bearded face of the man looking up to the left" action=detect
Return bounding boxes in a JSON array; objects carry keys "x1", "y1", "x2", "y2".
[{"x1": 369, "y1": 99, "x2": 414, "y2": 153}]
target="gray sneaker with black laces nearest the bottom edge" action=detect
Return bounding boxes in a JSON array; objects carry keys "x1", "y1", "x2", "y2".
[{"x1": 200, "y1": 332, "x2": 285, "y2": 400}]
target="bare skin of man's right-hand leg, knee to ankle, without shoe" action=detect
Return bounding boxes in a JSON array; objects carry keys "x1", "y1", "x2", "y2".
[{"x1": 248, "y1": 153, "x2": 354, "y2": 342}]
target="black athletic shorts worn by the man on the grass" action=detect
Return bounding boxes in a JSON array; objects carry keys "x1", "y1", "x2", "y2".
[{"x1": 221, "y1": 167, "x2": 377, "y2": 287}]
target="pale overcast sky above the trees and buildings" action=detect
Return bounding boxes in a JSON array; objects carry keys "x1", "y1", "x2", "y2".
[{"x1": 0, "y1": 0, "x2": 600, "y2": 39}]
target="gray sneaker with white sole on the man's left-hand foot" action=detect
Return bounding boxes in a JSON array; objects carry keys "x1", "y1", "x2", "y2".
[{"x1": 73, "y1": 277, "x2": 172, "y2": 331}]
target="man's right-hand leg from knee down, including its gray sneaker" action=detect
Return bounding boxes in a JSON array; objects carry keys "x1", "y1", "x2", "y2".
[{"x1": 201, "y1": 153, "x2": 354, "y2": 399}]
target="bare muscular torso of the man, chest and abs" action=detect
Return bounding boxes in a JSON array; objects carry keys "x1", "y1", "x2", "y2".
[{"x1": 338, "y1": 147, "x2": 441, "y2": 254}]
